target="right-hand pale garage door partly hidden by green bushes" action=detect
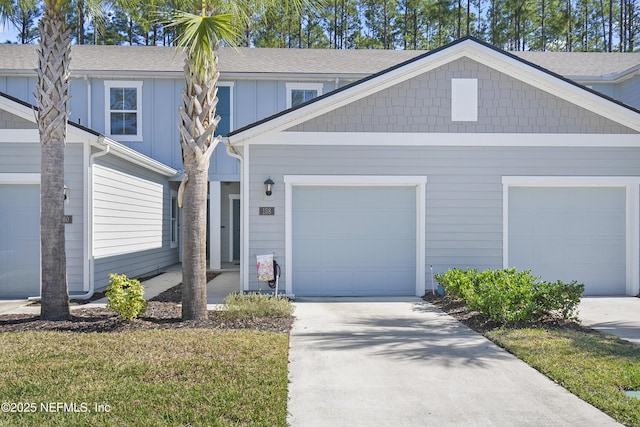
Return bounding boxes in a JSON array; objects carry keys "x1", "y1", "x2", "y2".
[{"x1": 509, "y1": 187, "x2": 626, "y2": 295}]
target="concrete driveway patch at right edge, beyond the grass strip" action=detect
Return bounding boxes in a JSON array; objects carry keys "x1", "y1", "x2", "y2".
[{"x1": 578, "y1": 297, "x2": 640, "y2": 345}]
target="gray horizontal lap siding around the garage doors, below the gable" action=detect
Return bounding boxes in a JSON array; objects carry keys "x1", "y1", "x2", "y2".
[{"x1": 245, "y1": 145, "x2": 640, "y2": 290}]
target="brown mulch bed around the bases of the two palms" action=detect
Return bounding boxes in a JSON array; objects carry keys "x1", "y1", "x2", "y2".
[{"x1": 0, "y1": 273, "x2": 293, "y2": 333}]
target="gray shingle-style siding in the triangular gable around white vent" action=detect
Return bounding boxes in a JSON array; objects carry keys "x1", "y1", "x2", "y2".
[{"x1": 290, "y1": 58, "x2": 636, "y2": 134}]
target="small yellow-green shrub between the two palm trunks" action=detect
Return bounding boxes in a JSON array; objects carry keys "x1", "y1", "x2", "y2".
[{"x1": 105, "y1": 273, "x2": 147, "y2": 320}]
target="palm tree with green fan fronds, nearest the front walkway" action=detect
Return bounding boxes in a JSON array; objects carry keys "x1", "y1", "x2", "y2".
[{"x1": 167, "y1": 0, "x2": 304, "y2": 320}]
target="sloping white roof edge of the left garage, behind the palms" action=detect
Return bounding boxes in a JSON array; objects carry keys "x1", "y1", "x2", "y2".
[{"x1": 0, "y1": 92, "x2": 178, "y2": 177}]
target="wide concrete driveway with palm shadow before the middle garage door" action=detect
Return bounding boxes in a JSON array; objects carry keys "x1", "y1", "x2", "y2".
[{"x1": 288, "y1": 298, "x2": 619, "y2": 427}]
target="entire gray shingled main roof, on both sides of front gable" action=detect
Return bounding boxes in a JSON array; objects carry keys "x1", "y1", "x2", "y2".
[{"x1": 0, "y1": 44, "x2": 640, "y2": 81}]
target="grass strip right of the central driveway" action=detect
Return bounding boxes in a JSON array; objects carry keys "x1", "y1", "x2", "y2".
[{"x1": 486, "y1": 328, "x2": 640, "y2": 426}]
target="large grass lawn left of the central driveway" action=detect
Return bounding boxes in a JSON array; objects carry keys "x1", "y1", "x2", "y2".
[{"x1": 0, "y1": 329, "x2": 288, "y2": 426}]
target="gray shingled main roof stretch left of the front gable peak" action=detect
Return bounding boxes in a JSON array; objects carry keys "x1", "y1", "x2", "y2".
[{"x1": 0, "y1": 44, "x2": 422, "y2": 78}]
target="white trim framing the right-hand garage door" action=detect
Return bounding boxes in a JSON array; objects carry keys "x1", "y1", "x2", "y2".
[{"x1": 502, "y1": 176, "x2": 640, "y2": 296}]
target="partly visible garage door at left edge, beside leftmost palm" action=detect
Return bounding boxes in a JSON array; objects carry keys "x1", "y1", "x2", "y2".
[{"x1": 0, "y1": 184, "x2": 40, "y2": 298}]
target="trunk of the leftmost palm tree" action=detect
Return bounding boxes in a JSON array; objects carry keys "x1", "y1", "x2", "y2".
[{"x1": 38, "y1": 9, "x2": 70, "y2": 320}]
